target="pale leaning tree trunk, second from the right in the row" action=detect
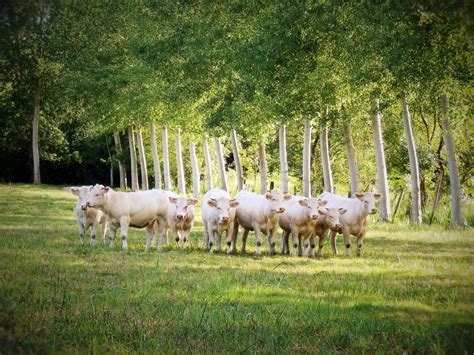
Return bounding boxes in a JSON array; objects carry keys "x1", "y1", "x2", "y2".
[{"x1": 400, "y1": 94, "x2": 421, "y2": 224}]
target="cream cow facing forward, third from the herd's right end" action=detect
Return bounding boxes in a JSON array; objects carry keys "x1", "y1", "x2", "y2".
[{"x1": 278, "y1": 196, "x2": 326, "y2": 255}]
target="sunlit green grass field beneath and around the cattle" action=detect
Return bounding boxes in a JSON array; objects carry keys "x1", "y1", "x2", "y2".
[{"x1": 0, "y1": 185, "x2": 474, "y2": 354}]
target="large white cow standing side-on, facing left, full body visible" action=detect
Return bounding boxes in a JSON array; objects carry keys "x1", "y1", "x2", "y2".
[{"x1": 86, "y1": 184, "x2": 169, "y2": 251}]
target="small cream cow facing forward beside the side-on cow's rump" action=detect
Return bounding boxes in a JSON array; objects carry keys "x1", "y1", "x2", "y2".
[{"x1": 162, "y1": 191, "x2": 199, "y2": 244}]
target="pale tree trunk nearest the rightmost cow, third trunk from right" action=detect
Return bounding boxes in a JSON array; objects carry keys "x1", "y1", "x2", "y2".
[{"x1": 371, "y1": 99, "x2": 391, "y2": 222}]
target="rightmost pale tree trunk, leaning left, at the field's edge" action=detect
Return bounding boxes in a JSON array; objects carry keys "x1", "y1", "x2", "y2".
[{"x1": 441, "y1": 94, "x2": 464, "y2": 227}]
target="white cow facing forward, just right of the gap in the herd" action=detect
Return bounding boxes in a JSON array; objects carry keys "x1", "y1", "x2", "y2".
[{"x1": 201, "y1": 189, "x2": 239, "y2": 254}]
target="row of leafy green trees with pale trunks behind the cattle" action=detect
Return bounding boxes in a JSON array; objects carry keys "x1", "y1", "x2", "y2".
[{"x1": 0, "y1": 0, "x2": 472, "y2": 225}]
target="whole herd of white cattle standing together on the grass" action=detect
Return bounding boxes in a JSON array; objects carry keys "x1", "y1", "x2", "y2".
[{"x1": 70, "y1": 184, "x2": 382, "y2": 256}]
